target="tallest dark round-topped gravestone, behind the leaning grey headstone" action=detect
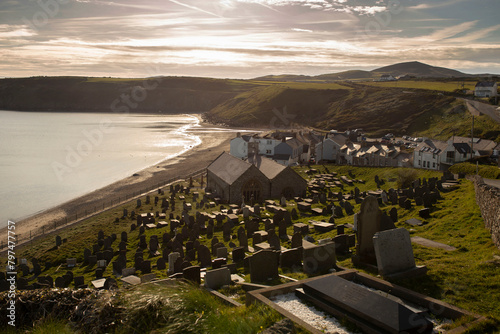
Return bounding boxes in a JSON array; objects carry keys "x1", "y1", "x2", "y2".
[{"x1": 353, "y1": 196, "x2": 395, "y2": 264}]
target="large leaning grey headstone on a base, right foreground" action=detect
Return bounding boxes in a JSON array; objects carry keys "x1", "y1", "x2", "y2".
[{"x1": 373, "y1": 228, "x2": 427, "y2": 278}]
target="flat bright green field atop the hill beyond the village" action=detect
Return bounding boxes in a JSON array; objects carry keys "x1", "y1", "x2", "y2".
[{"x1": 363, "y1": 80, "x2": 477, "y2": 92}]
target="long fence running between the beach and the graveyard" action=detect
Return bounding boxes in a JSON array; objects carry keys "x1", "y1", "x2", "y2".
[{"x1": 0, "y1": 168, "x2": 206, "y2": 251}]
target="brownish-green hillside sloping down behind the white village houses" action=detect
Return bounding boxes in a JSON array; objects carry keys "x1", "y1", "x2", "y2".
[{"x1": 209, "y1": 85, "x2": 455, "y2": 135}]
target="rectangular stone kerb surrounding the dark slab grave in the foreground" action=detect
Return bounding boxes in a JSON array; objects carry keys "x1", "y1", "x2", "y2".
[{"x1": 246, "y1": 269, "x2": 487, "y2": 334}]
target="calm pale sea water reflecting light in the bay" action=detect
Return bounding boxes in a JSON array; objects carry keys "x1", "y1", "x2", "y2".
[{"x1": 0, "y1": 111, "x2": 203, "y2": 227}]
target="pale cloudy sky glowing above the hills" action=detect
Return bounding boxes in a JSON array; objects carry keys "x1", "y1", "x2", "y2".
[{"x1": 0, "y1": 0, "x2": 500, "y2": 79}]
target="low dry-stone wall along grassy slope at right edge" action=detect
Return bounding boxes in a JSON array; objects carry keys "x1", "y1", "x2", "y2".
[{"x1": 470, "y1": 176, "x2": 500, "y2": 249}]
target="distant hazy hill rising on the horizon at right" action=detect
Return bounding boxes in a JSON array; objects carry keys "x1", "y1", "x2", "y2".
[{"x1": 255, "y1": 61, "x2": 491, "y2": 82}]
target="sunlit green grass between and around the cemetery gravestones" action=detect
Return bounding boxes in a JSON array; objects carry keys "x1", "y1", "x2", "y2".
[{"x1": 4, "y1": 166, "x2": 500, "y2": 333}]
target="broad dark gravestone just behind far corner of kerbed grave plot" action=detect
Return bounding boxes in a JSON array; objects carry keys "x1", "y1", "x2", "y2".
[{"x1": 302, "y1": 242, "x2": 337, "y2": 274}]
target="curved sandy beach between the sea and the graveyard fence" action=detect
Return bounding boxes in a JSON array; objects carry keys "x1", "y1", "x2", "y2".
[{"x1": 0, "y1": 117, "x2": 241, "y2": 242}]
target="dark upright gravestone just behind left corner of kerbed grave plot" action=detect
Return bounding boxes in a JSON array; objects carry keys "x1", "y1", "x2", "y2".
[{"x1": 249, "y1": 249, "x2": 279, "y2": 283}]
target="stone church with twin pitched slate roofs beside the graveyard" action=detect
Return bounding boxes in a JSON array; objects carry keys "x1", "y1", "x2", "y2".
[{"x1": 207, "y1": 152, "x2": 307, "y2": 204}]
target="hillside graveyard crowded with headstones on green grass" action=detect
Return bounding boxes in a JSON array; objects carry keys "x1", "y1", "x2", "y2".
[{"x1": 0, "y1": 165, "x2": 500, "y2": 333}]
